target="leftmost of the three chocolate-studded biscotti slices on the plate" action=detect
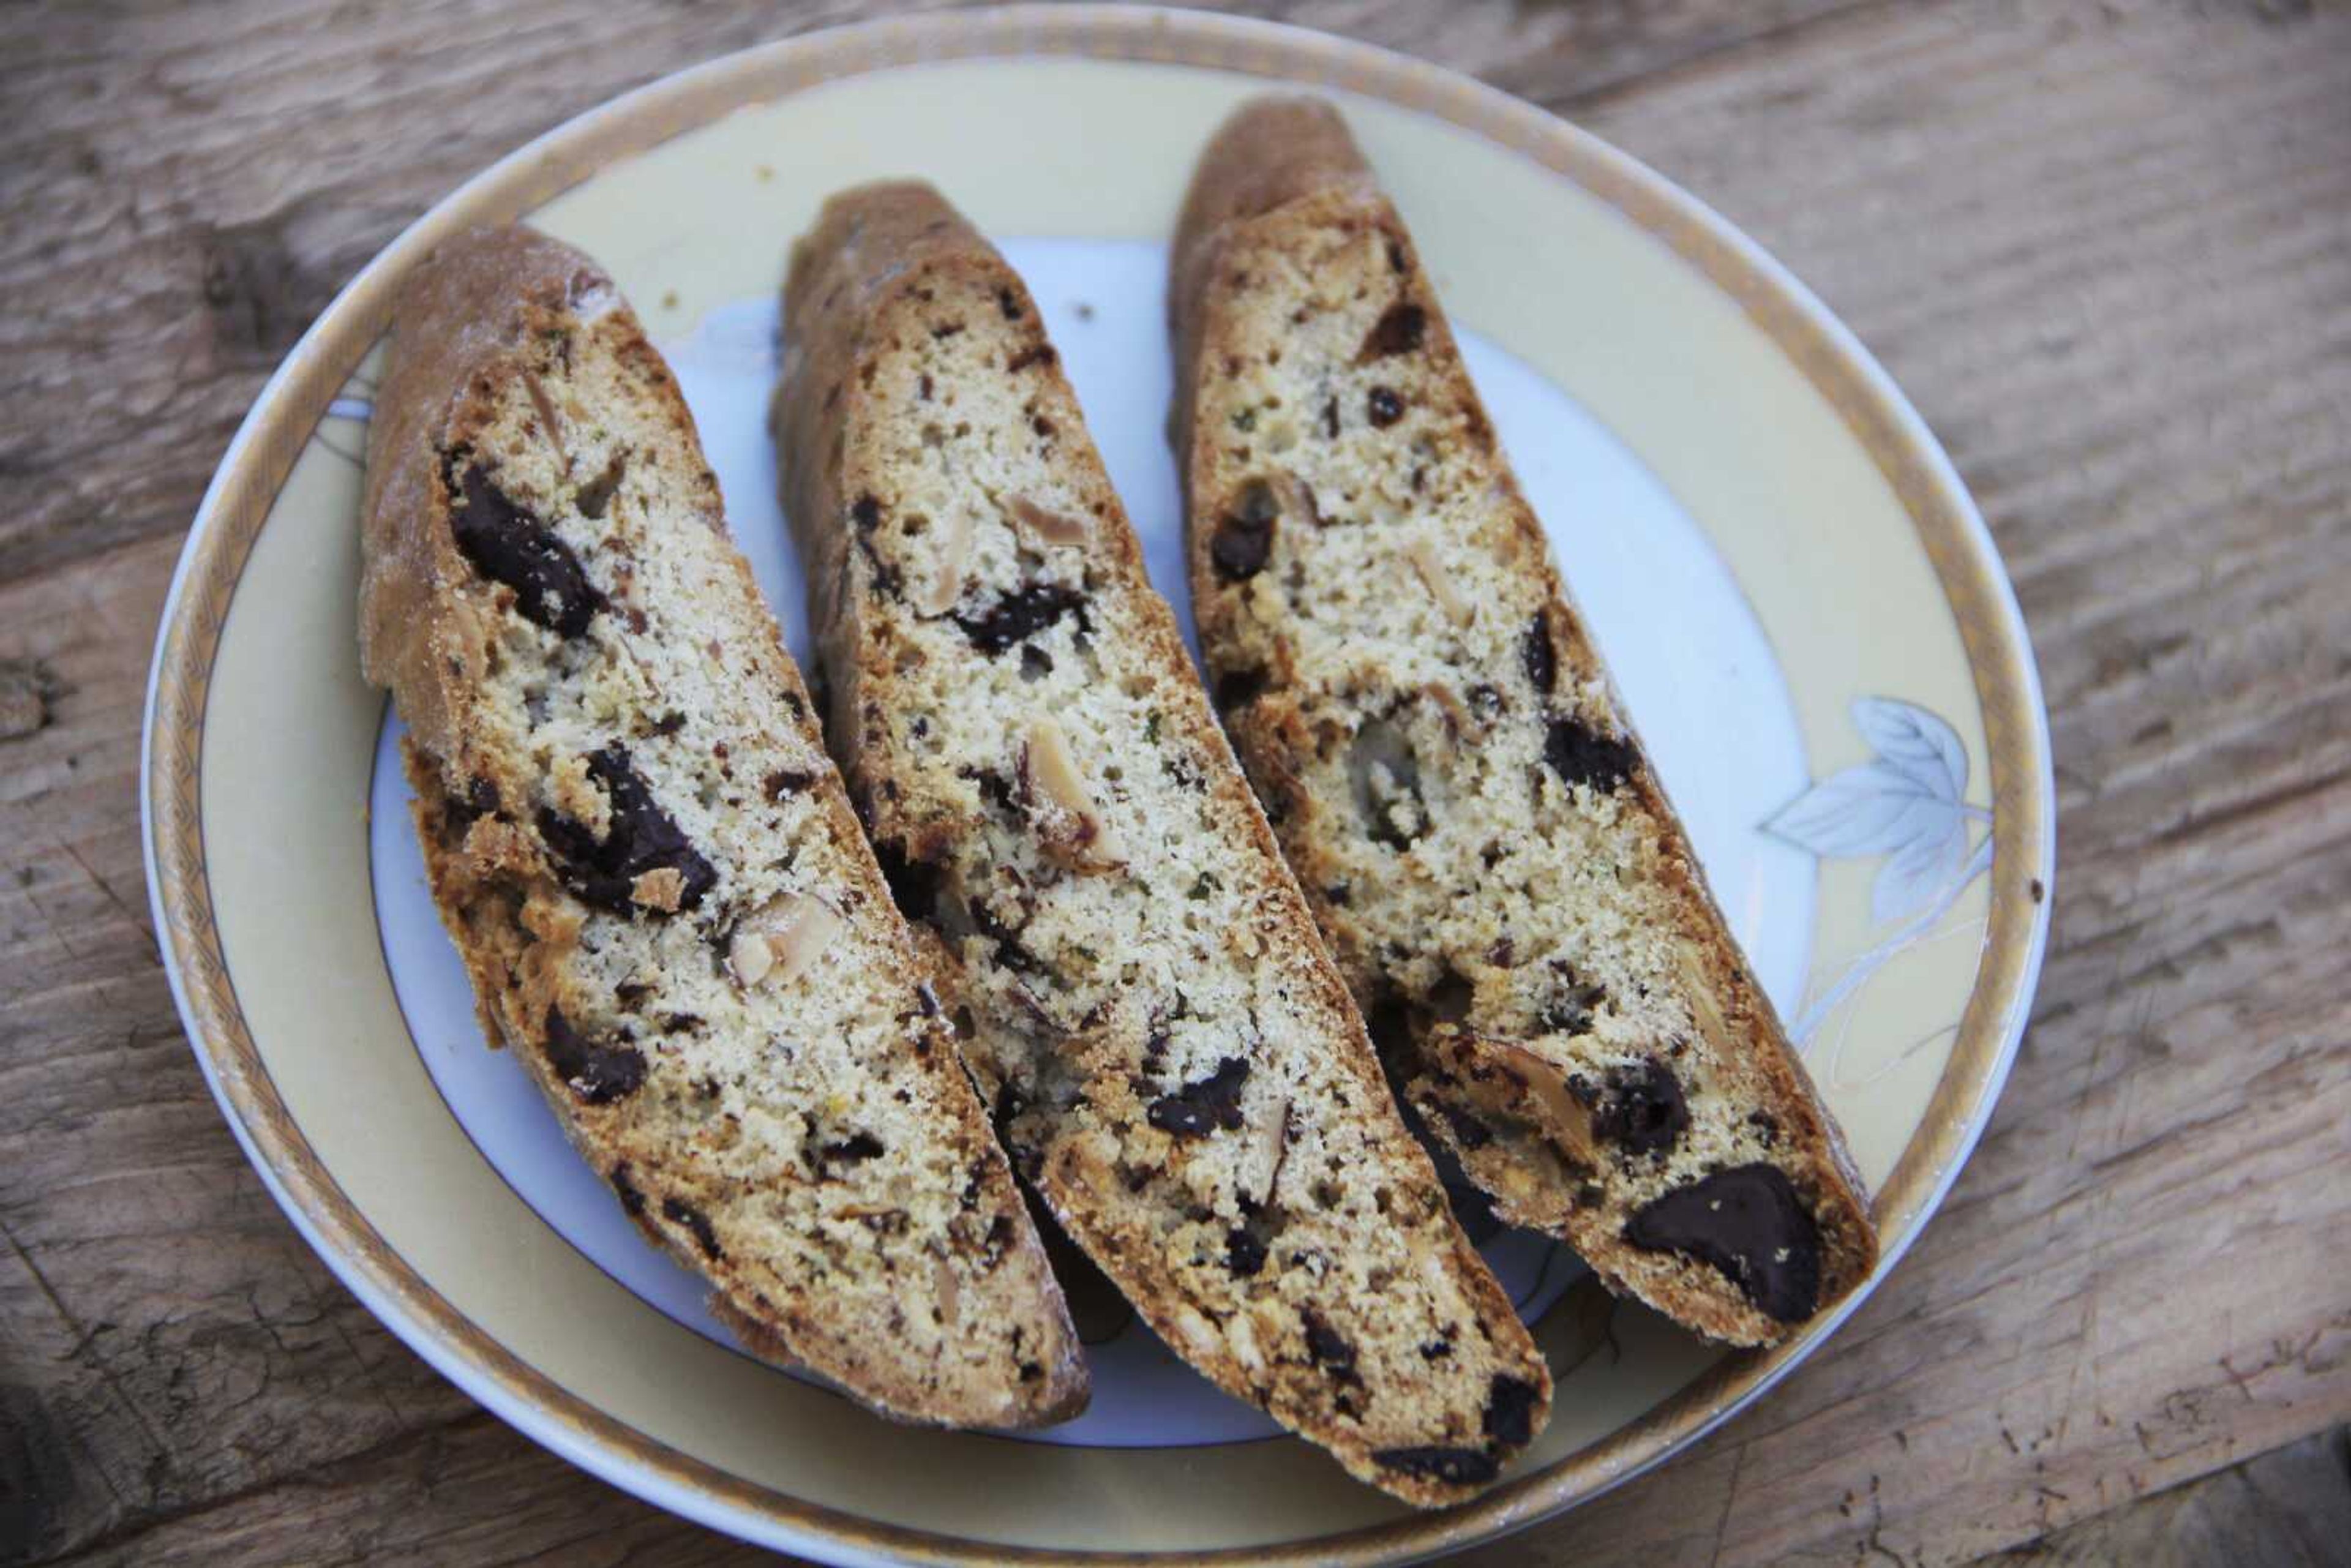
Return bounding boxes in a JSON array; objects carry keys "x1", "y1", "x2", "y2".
[{"x1": 360, "y1": 228, "x2": 1086, "y2": 1427}]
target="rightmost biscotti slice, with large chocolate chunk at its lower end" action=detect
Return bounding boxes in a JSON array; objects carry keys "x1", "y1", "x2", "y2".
[{"x1": 1171, "y1": 99, "x2": 1876, "y2": 1345}]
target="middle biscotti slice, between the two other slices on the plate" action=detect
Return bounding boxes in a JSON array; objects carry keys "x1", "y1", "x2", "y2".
[{"x1": 776, "y1": 186, "x2": 1550, "y2": 1504}]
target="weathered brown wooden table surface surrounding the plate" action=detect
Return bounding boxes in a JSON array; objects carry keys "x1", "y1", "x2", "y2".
[{"x1": 0, "y1": 0, "x2": 2351, "y2": 1566}]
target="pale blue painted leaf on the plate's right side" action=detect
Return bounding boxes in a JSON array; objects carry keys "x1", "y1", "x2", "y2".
[{"x1": 1763, "y1": 696, "x2": 1968, "y2": 921}]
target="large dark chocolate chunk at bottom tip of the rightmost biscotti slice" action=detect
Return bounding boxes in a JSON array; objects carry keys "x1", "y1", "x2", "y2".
[{"x1": 1624, "y1": 1164, "x2": 1820, "y2": 1324}]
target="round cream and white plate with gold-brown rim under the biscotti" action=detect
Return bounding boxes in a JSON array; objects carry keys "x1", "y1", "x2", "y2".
[{"x1": 146, "y1": 7, "x2": 2052, "y2": 1561}]
